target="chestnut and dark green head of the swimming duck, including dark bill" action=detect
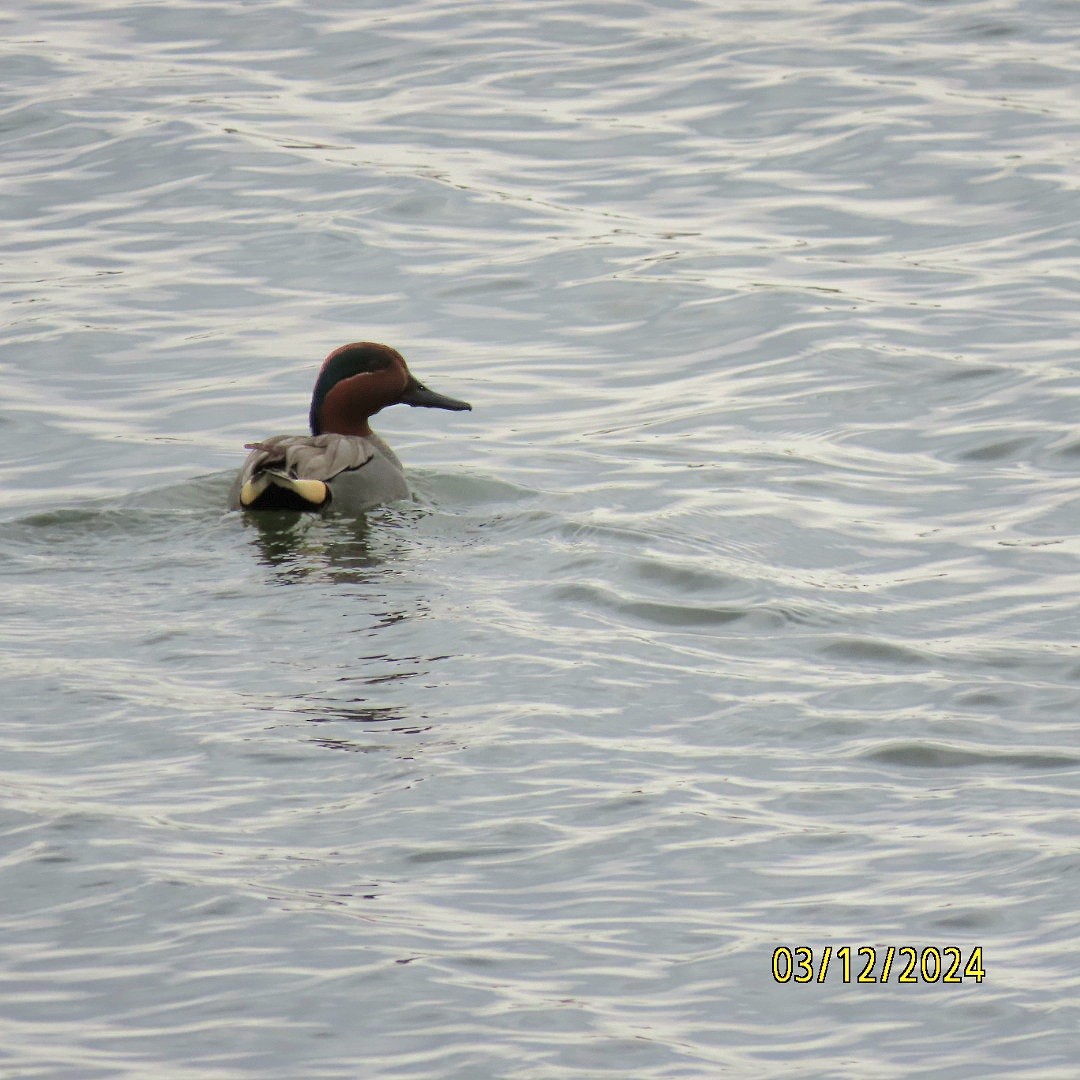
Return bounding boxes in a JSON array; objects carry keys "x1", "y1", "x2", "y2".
[{"x1": 309, "y1": 341, "x2": 472, "y2": 435}]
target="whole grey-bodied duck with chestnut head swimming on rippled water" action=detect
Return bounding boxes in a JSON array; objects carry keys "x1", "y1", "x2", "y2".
[{"x1": 229, "y1": 341, "x2": 472, "y2": 515}]
